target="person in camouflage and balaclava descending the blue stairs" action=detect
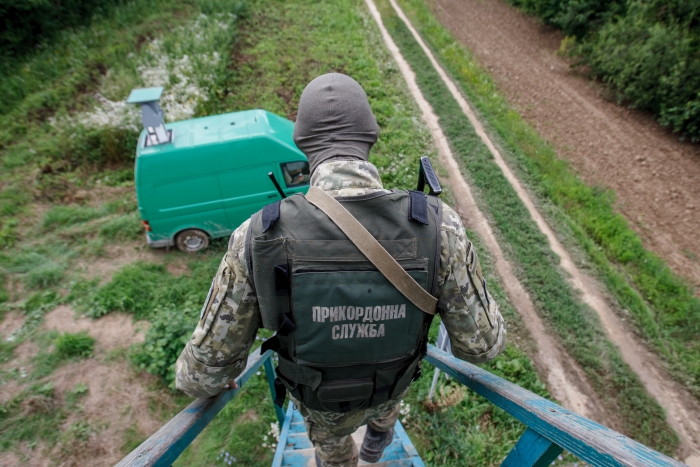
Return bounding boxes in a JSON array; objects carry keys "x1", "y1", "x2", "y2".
[{"x1": 177, "y1": 73, "x2": 506, "y2": 467}]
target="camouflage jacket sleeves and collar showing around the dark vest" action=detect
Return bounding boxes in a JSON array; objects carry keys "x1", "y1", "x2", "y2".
[{"x1": 176, "y1": 161, "x2": 506, "y2": 397}]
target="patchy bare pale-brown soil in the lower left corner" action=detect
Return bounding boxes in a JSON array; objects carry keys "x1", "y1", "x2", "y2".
[{"x1": 0, "y1": 306, "x2": 174, "y2": 467}]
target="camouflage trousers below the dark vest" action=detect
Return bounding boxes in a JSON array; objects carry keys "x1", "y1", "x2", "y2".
[{"x1": 290, "y1": 391, "x2": 408, "y2": 467}]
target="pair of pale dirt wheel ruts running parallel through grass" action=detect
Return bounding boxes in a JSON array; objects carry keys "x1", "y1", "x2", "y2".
[{"x1": 374, "y1": 0, "x2": 700, "y2": 464}]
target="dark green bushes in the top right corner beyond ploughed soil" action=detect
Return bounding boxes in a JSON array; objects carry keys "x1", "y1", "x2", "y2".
[{"x1": 510, "y1": 0, "x2": 700, "y2": 141}]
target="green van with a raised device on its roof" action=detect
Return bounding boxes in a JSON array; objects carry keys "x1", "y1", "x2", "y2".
[{"x1": 135, "y1": 109, "x2": 309, "y2": 253}]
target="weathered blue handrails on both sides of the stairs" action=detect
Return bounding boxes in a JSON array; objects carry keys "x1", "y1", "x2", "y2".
[{"x1": 117, "y1": 345, "x2": 685, "y2": 467}]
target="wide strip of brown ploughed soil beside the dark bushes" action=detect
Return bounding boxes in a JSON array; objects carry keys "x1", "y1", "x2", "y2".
[{"x1": 433, "y1": 0, "x2": 700, "y2": 285}]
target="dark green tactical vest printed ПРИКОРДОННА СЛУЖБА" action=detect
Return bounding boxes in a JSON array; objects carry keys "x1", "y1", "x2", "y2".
[{"x1": 246, "y1": 191, "x2": 442, "y2": 413}]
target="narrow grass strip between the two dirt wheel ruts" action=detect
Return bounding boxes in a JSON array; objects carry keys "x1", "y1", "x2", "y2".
[{"x1": 374, "y1": 2, "x2": 678, "y2": 453}]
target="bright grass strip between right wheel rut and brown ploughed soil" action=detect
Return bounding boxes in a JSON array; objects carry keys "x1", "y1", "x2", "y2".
[{"x1": 394, "y1": 0, "x2": 700, "y2": 398}]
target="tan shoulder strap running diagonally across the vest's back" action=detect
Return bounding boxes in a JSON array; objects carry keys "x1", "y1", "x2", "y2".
[{"x1": 306, "y1": 186, "x2": 437, "y2": 315}]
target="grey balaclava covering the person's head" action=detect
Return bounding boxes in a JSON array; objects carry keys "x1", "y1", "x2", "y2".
[{"x1": 294, "y1": 73, "x2": 379, "y2": 174}]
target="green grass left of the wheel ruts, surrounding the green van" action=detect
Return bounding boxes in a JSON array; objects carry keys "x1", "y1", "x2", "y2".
[{"x1": 0, "y1": 0, "x2": 656, "y2": 465}]
